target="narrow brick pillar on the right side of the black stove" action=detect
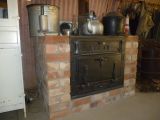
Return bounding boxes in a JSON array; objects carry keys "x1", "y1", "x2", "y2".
[{"x1": 124, "y1": 36, "x2": 138, "y2": 96}]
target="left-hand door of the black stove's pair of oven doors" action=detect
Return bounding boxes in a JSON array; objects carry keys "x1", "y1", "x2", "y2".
[{"x1": 76, "y1": 55, "x2": 101, "y2": 84}]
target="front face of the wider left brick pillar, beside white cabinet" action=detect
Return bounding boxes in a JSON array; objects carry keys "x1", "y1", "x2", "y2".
[{"x1": 44, "y1": 36, "x2": 71, "y2": 120}]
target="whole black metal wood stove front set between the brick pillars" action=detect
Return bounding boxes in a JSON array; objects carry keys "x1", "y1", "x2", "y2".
[{"x1": 70, "y1": 36, "x2": 125, "y2": 99}]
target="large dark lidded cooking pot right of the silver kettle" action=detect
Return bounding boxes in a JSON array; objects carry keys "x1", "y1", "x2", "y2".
[{"x1": 103, "y1": 12, "x2": 125, "y2": 35}]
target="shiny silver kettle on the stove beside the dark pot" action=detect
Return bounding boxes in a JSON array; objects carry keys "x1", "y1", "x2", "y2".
[{"x1": 82, "y1": 11, "x2": 103, "y2": 35}]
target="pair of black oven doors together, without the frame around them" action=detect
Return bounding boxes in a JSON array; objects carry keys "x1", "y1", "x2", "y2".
[{"x1": 72, "y1": 54, "x2": 123, "y2": 85}]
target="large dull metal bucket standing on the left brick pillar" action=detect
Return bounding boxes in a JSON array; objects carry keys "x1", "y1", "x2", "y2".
[{"x1": 27, "y1": 4, "x2": 59, "y2": 36}]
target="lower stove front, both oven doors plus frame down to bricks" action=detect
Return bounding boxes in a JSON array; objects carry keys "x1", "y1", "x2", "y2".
[{"x1": 71, "y1": 54, "x2": 123, "y2": 98}]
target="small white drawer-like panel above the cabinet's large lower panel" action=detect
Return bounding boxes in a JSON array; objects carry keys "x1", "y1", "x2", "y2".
[{"x1": 0, "y1": 31, "x2": 18, "y2": 44}]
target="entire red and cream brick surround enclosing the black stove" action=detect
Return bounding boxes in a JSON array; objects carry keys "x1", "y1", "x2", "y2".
[{"x1": 35, "y1": 36, "x2": 138, "y2": 120}]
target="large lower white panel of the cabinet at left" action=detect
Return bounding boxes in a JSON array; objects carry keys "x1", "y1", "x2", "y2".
[{"x1": 0, "y1": 49, "x2": 24, "y2": 107}]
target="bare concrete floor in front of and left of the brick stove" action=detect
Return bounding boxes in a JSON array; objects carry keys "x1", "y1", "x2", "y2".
[{"x1": 0, "y1": 93, "x2": 160, "y2": 120}]
